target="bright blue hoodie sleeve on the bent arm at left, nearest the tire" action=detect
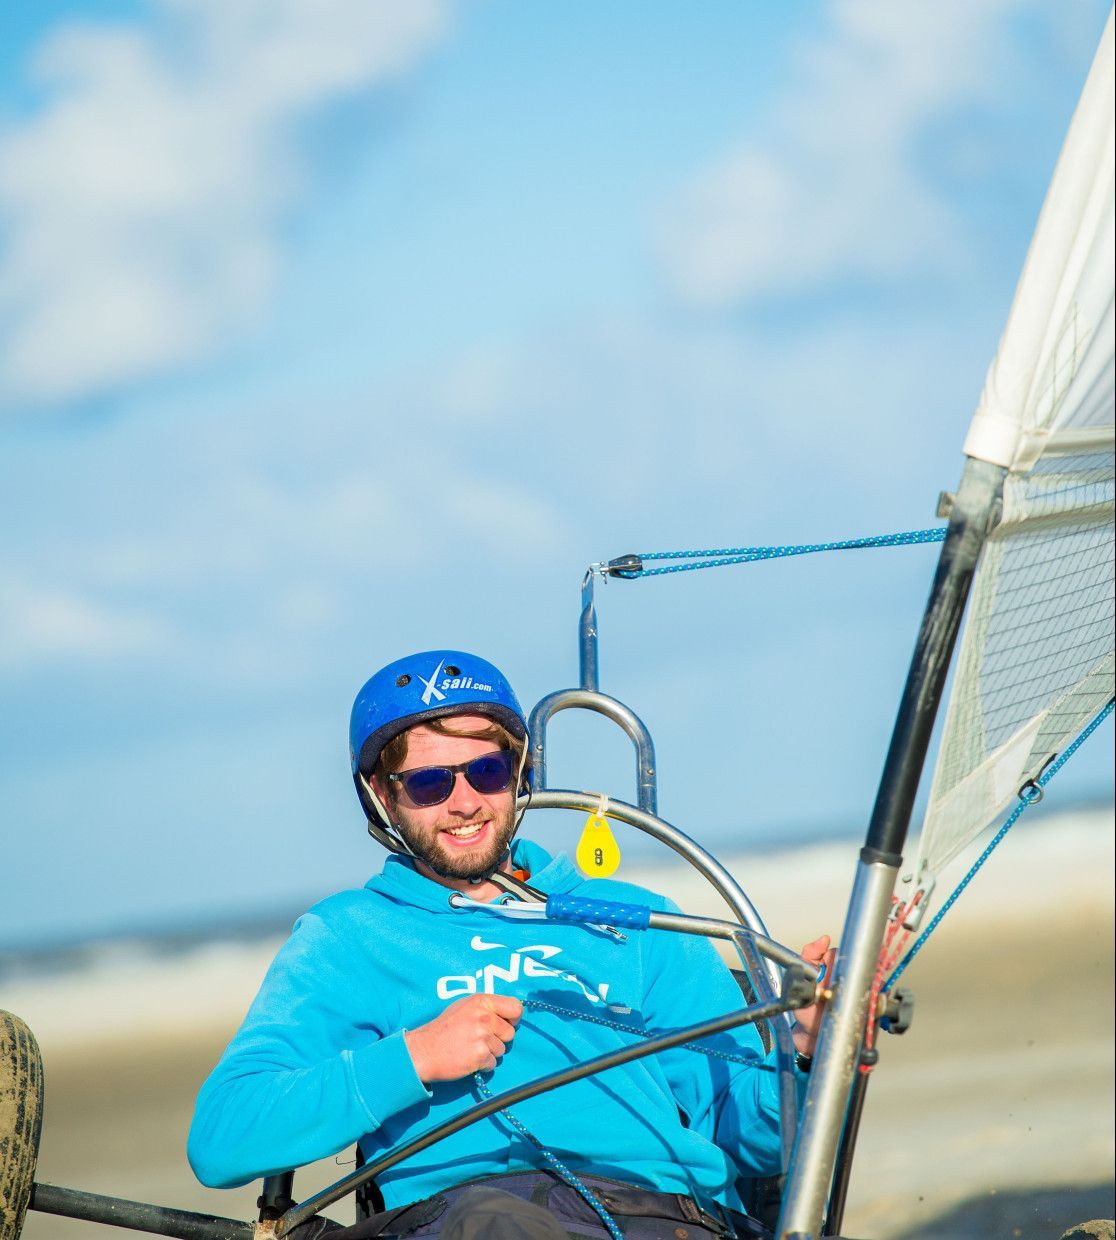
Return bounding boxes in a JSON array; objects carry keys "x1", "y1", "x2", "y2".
[{"x1": 187, "y1": 913, "x2": 430, "y2": 1188}]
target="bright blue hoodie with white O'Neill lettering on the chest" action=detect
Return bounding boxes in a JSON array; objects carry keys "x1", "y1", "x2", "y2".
[{"x1": 188, "y1": 841, "x2": 780, "y2": 1209}]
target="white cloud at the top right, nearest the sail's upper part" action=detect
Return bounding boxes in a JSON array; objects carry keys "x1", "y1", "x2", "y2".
[{"x1": 660, "y1": 0, "x2": 1036, "y2": 306}]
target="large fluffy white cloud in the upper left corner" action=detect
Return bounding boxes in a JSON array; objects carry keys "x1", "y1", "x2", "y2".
[{"x1": 0, "y1": 0, "x2": 446, "y2": 405}]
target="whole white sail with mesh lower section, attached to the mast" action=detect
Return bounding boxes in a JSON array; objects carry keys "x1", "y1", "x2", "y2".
[{"x1": 916, "y1": 12, "x2": 1116, "y2": 882}]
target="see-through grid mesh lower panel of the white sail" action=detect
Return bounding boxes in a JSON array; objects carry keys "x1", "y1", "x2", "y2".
[{"x1": 920, "y1": 451, "x2": 1116, "y2": 874}]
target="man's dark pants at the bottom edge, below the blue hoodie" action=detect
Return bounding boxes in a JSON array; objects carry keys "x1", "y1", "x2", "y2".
[{"x1": 310, "y1": 1171, "x2": 770, "y2": 1240}]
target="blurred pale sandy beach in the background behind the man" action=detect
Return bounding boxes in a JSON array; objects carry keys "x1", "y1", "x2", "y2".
[{"x1": 0, "y1": 811, "x2": 1114, "y2": 1240}]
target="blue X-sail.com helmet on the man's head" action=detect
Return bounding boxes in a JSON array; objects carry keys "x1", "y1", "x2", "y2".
[{"x1": 348, "y1": 650, "x2": 527, "y2": 822}]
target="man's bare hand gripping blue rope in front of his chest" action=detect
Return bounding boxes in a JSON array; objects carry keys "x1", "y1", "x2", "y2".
[{"x1": 403, "y1": 994, "x2": 523, "y2": 1085}]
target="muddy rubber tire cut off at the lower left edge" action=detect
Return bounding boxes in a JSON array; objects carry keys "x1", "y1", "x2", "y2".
[{"x1": 0, "y1": 1012, "x2": 42, "y2": 1240}]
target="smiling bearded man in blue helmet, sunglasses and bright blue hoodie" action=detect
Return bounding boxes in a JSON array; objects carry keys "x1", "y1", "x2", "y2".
[{"x1": 188, "y1": 651, "x2": 832, "y2": 1240}]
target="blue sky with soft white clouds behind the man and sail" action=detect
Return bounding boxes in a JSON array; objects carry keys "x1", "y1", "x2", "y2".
[{"x1": 0, "y1": 0, "x2": 1111, "y2": 941}]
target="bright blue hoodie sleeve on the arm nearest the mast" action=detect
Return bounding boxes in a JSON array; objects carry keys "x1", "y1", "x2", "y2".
[{"x1": 644, "y1": 900, "x2": 781, "y2": 1177}]
